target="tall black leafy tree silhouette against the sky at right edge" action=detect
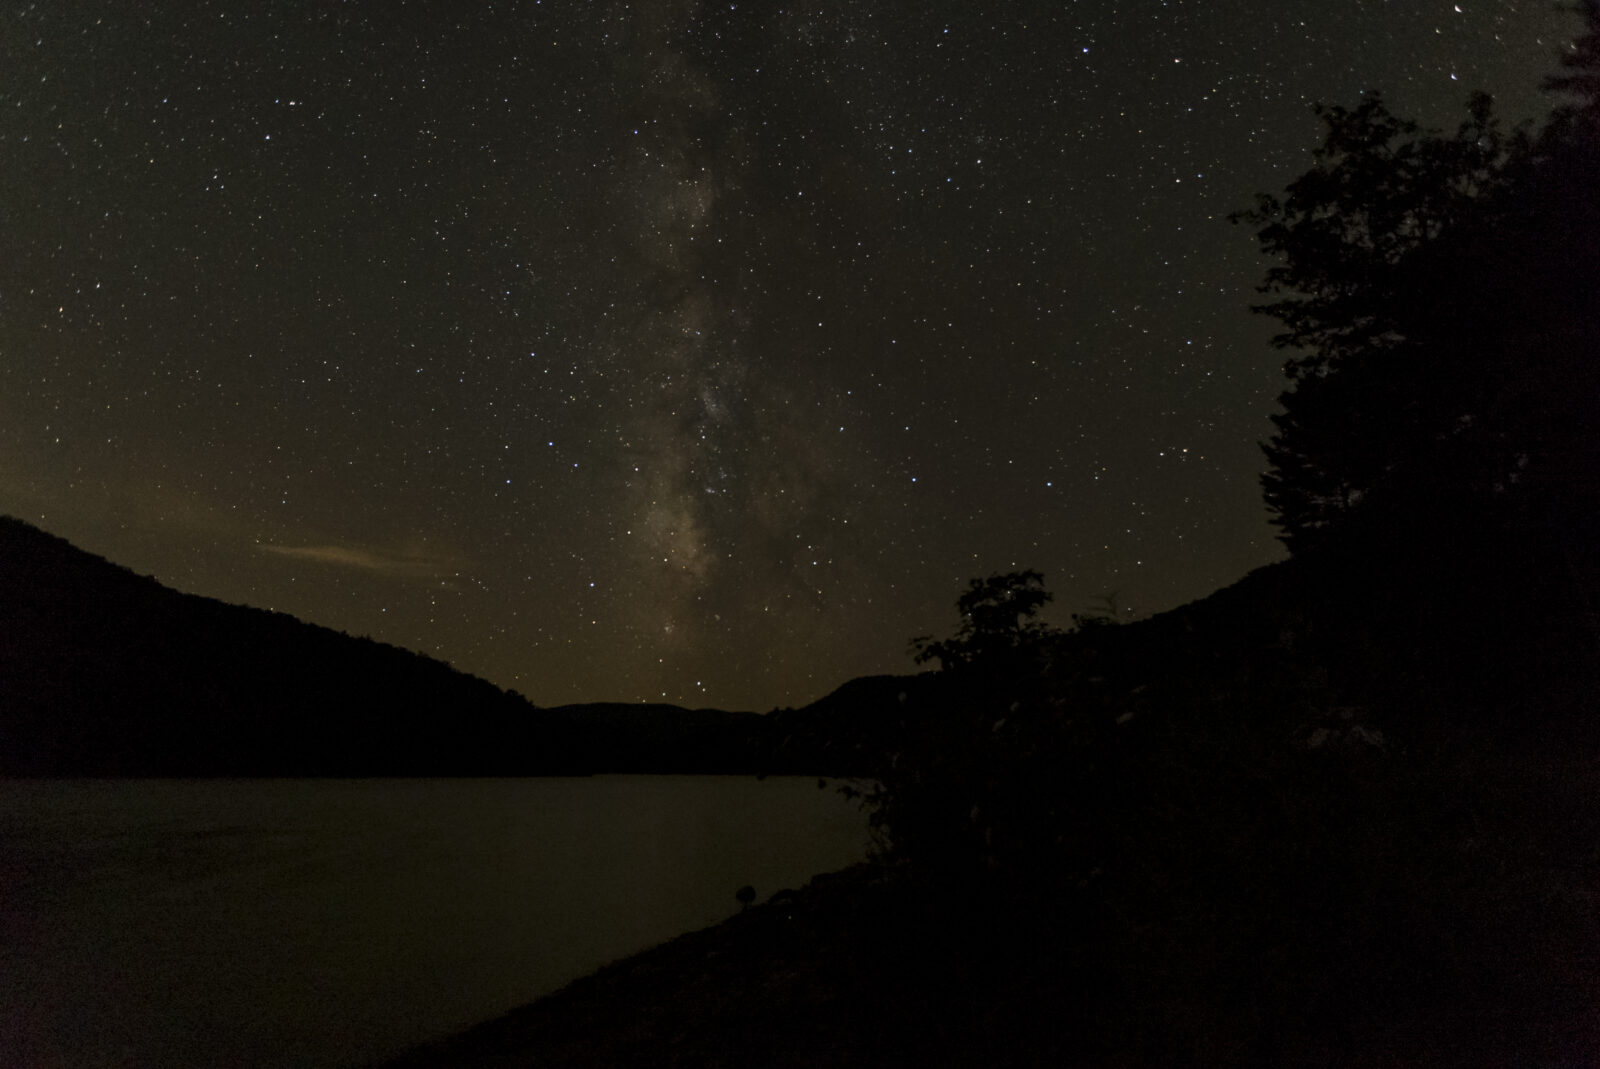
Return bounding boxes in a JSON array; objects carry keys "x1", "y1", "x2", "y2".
[{"x1": 1235, "y1": 8, "x2": 1600, "y2": 551}]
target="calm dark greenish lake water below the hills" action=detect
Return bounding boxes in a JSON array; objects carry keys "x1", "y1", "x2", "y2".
[{"x1": 0, "y1": 776, "x2": 867, "y2": 1069}]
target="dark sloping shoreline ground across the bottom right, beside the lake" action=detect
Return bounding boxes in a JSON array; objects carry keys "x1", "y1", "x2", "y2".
[{"x1": 366, "y1": 784, "x2": 1600, "y2": 1069}]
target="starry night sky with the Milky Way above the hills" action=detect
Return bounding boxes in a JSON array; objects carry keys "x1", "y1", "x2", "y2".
[{"x1": 0, "y1": 0, "x2": 1579, "y2": 709}]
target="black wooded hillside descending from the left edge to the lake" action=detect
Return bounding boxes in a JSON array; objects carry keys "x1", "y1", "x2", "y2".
[{"x1": 0, "y1": 517, "x2": 579, "y2": 775}]
